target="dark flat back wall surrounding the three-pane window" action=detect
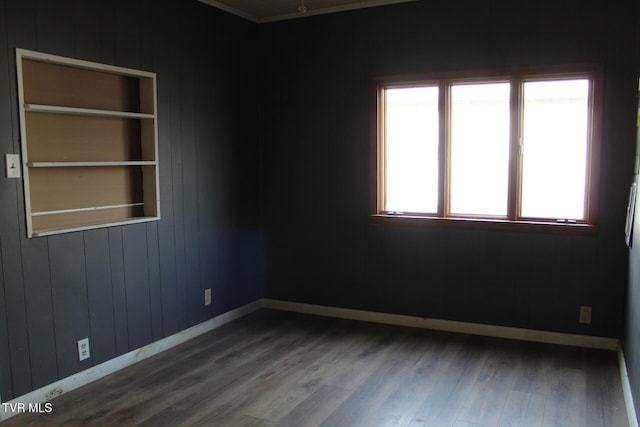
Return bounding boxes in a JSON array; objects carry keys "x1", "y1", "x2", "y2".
[{"x1": 260, "y1": 0, "x2": 639, "y2": 337}]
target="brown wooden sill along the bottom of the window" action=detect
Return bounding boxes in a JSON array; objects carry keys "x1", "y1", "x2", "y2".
[{"x1": 369, "y1": 214, "x2": 598, "y2": 236}]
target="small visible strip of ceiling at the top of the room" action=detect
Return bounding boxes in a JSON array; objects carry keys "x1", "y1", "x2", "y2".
[{"x1": 199, "y1": 0, "x2": 414, "y2": 23}]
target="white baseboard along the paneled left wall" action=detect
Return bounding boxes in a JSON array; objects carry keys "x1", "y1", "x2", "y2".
[{"x1": 0, "y1": 300, "x2": 262, "y2": 422}]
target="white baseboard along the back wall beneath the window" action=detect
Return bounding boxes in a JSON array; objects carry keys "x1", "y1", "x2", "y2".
[{"x1": 262, "y1": 299, "x2": 619, "y2": 351}]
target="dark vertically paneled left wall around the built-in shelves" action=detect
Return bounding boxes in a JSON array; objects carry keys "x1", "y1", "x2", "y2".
[{"x1": 0, "y1": 0, "x2": 263, "y2": 401}]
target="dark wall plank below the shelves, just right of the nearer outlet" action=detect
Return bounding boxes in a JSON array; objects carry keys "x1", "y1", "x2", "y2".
[{"x1": 83, "y1": 229, "x2": 116, "y2": 365}]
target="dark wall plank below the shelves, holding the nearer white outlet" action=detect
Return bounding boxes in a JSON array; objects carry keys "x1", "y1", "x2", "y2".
[{"x1": 47, "y1": 233, "x2": 91, "y2": 378}]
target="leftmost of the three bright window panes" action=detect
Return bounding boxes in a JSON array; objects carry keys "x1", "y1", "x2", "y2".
[{"x1": 385, "y1": 86, "x2": 438, "y2": 213}]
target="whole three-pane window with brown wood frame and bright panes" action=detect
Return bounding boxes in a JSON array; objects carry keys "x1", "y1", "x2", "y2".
[{"x1": 370, "y1": 64, "x2": 603, "y2": 229}]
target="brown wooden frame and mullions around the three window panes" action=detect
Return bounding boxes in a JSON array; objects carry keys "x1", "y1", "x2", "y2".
[{"x1": 370, "y1": 64, "x2": 603, "y2": 234}]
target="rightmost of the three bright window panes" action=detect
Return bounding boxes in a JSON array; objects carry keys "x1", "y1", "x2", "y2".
[{"x1": 522, "y1": 79, "x2": 589, "y2": 220}]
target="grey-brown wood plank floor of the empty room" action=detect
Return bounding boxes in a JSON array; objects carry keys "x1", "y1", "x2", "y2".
[{"x1": 0, "y1": 310, "x2": 628, "y2": 427}]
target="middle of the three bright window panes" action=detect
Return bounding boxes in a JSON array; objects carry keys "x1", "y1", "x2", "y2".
[{"x1": 450, "y1": 83, "x2": 511, "y2": 216}]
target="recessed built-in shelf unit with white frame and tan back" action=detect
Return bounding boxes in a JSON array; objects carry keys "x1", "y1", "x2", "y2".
[{"x1": 16, "y1": 49, "x2": 160, "y2": 241}]
